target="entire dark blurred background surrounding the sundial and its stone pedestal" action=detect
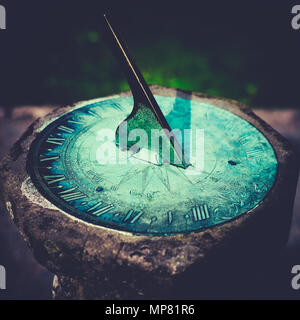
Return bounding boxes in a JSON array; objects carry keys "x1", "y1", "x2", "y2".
[{"x1": 0, "y1": 0, "x2": 300, "y2": 299}]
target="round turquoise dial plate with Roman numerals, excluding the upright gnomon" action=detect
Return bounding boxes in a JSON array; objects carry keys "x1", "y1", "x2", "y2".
[{"x1": 27, "y1": 96, "x2": 277, "y2": 236}]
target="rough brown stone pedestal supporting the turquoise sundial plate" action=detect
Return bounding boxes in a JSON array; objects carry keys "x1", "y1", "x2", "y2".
[{"x1": 0, "y1": 86, "x2": 299, "y2": 299}]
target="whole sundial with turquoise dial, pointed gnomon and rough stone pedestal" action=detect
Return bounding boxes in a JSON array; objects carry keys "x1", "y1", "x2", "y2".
[{"x1": 1, "y1": 16, "x2": 298, "y2": 298}]
